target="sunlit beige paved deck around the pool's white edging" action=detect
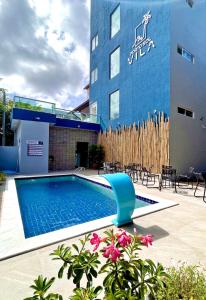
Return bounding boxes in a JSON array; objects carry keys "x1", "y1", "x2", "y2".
[{"x1": 0, "y1": 171, "x2": 206, "y2": 300}]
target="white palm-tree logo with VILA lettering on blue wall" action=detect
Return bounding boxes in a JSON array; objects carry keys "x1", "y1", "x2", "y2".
[{"x1": 128, "y1": 11, "x2": 155, "y2": 65}]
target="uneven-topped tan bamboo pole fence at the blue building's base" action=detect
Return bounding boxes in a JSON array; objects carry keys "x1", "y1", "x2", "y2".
[{"x1": 98, "y1": 113, "x2": 170, "y2": 172}]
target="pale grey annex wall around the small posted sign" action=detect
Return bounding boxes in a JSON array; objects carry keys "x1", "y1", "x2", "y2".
[{"x1": 16, "y1": 121, "x2": 49, "y2": 174}]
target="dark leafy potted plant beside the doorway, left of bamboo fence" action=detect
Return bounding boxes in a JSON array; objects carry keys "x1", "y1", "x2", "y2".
[{"x1": 89, "y1": 145, "x2": 105, "y2": 169}]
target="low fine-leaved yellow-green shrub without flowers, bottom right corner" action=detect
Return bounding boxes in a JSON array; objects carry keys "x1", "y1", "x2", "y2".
[{"x1": 157, "y1": 264, "x2": 206, "y2": 300}]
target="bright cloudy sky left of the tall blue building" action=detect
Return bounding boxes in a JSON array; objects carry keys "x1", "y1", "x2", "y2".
[{"x1": 0, "y1": 0, "x2": 90, "y2": 109}]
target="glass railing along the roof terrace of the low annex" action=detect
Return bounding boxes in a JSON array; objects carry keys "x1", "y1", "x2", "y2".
[{"x1": 14, "y1": 96, "x2": 100, "y2": 124}]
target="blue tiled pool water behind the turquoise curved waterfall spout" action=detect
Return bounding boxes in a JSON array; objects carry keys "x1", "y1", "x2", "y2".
[{"x1": 16, "y1": 175, "x2": 155, "y2": 238}]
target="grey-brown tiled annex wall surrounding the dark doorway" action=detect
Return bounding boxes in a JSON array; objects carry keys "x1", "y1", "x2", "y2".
[{"x1": 49, "y1": 127, "x2": 97, "y2": 171}]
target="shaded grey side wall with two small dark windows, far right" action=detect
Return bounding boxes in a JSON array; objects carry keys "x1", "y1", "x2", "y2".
[{"x1": 170, "y1": 1, "x2": 206, "y2": 172}]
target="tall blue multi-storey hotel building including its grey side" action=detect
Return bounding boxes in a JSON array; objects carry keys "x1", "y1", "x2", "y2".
[{"x1": 90, "y1": 0, "x2": 206, "y2": 171}]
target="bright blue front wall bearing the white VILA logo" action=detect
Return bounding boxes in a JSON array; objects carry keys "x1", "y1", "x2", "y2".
[{"x1": 90, "y1": 0, "x2": 170, "y2": 127}]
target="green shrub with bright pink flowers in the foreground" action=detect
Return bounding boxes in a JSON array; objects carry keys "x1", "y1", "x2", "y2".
[{"x1": 25, "y1": 229, "x2": 168, "y2": 300}]
